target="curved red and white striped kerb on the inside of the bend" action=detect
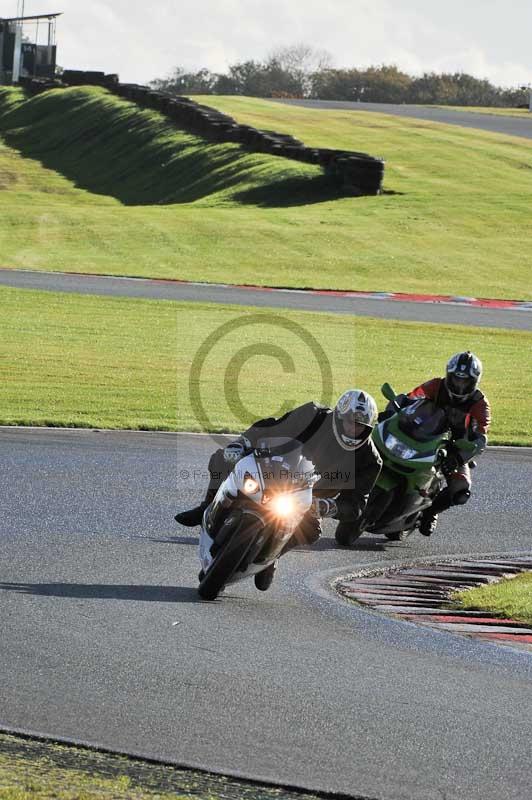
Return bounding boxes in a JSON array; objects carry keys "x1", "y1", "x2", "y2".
[{"x1": 335, "y1": 555, "x2": 532, "y2": 652}]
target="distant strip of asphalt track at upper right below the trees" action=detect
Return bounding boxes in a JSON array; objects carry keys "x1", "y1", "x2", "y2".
[{"x1": 275, "y1": 100, "x2": 532, "y2": 139}]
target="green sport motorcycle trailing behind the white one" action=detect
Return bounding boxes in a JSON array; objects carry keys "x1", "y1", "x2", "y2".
[{"x1": 337, "y1": 383, "x2": 472, "y2": 547}]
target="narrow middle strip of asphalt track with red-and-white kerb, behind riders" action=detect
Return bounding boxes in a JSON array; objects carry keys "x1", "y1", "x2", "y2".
[{"x1": 0, "y1": 268, "x2": 532, "y2": 330}]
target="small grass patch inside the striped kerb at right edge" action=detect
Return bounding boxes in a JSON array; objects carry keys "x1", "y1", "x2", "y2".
[{"x1": 453, "y1": 572, "x2": 532, "y2": 624}]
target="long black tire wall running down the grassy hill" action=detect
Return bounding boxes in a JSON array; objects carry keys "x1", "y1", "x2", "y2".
[{"x1": 19, "y1": 69, "x2": 385, "y2": 196}]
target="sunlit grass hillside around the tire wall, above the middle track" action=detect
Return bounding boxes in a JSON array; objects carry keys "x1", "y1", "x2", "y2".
[{"x1": 0, "y1": 88, "x2": 532, "y2": 299}]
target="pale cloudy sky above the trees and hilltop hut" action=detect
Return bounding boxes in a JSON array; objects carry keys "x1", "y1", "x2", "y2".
[{"x1": 4, "y1": 0, "x2": 532, "y2": 86}]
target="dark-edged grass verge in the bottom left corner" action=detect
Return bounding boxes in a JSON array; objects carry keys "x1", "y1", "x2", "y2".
[{"x1": 0, "y1": 733, "x2": 315, "y2": 800}]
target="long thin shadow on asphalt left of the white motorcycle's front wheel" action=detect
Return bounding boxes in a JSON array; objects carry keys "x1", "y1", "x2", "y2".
[{"x1": 0, "y1": 583, "x2": 203, "y2": 603}]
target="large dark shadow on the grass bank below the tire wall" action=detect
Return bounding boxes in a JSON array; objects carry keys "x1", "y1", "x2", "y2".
[{"x1": 0, "y1": 87, "x2": 352, "y2": 208}]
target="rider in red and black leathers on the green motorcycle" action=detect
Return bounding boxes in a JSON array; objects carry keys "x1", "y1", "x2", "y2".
[{"x1": 408, "y1": 351, "x2": 491, "y2": 536}]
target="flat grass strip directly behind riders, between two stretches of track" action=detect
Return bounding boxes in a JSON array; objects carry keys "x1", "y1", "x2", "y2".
[{"x1": 0, "y1": 288, "x2": 532, "y2": 444}]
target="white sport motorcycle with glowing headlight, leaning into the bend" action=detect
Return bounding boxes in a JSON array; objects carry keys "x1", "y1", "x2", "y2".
[{"x1": 198, "y1": 438, "x2": 320, "y2": 600}]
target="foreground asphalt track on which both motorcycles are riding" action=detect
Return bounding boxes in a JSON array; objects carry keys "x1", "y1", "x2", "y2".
[{"x1": 0, "y1": 428, "x2": 532, "y2": 800}]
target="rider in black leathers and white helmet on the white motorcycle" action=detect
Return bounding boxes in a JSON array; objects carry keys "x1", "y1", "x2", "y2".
[{"x1": 175, "y1": 389, "x2": 382, "y2": 550}]
